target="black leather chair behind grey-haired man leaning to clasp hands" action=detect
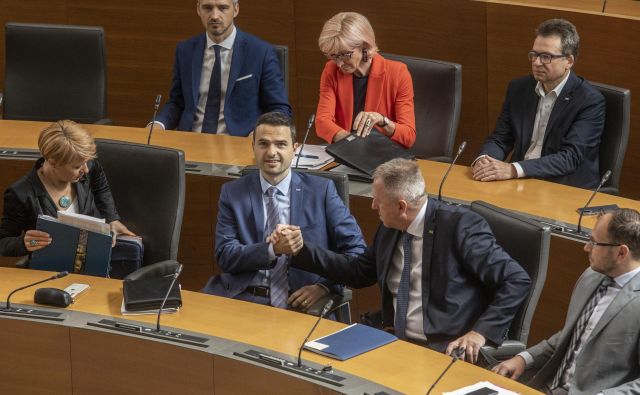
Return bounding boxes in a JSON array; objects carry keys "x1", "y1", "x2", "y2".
[{"x1": 471, "y1": 201, "x2": 551, "y2": 344}]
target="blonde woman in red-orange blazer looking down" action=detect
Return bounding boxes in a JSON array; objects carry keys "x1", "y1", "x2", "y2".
[{"x1": 316, "y1": 12, "x2": 416, "y2": 148}]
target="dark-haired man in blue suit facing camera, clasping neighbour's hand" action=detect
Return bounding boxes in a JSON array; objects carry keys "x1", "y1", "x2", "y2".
[{"x1": 202, "y1": 112, "x2": 365, "y2": 310}]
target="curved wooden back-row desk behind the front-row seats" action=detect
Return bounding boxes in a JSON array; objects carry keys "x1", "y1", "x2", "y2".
[{"x1": 0, "y1": 121, "x2": 640, "y2": 344}]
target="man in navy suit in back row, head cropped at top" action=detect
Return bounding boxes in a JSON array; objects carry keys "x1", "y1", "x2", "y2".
[{"x1": 156, "y1": 0, "x2": 291, "y2": 136}]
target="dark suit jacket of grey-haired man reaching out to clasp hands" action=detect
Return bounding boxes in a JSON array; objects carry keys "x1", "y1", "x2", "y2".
[{"x1": 292, "y1": 199, "x2": 531, "y2": 351}]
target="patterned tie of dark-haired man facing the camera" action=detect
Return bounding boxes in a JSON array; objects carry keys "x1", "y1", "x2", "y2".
[{"x1": 266, "y1": 187, "x2": 289, "y2": 308}]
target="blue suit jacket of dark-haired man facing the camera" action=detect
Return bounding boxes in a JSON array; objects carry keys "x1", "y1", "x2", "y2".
[{"x1": 203, "y1": 172, "x2": 365, "y2": 298}]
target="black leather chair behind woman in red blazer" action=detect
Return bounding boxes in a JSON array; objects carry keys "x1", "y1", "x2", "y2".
[{"x1": 382, "y1": 53, "x2": 462, "y2": 162}]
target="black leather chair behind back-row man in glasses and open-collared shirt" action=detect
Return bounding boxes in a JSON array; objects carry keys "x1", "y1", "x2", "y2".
[{"x1": 591, "y1": 82, "x2": 631, "y2": 195}]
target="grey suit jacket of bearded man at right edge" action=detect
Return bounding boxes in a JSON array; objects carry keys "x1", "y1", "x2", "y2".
[{"x1": 527, "y1": 268, "x2": 640, "y2": 395}]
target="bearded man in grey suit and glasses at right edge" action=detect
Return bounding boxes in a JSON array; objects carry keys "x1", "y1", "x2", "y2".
[{"x1": 493, "y1": 209, "x2": 640, "y2": 395}]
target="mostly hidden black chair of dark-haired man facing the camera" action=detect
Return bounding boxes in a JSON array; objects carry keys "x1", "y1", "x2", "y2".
[{"x1": 242, "y1": 166, "x2": 353, "y2": 324}]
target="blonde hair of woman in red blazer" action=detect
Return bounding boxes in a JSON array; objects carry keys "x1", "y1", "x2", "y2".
[{"x1": 318, "y1": 12, "x2": 378, "y2": 55}]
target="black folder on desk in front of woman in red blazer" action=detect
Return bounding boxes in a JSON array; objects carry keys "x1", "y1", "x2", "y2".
[{"x1": 326, "y1": 130, "x2": 415, "y2": 176}]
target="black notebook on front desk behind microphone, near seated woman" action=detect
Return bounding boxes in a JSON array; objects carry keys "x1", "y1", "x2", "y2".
[{"x1": 122, "y1": 276, "x2": 182, "y2": 311}]
